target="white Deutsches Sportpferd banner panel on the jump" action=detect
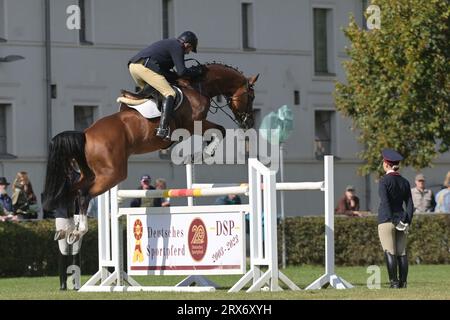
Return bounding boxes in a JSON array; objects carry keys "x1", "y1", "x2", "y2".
[{"x1": 127, "y1": 211, "x2": 245, "y2": 275}]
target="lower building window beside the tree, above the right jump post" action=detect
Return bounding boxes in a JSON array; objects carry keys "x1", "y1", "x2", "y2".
[{"x1": 314, "y1": 111, "x2": 334, "y2": 158}]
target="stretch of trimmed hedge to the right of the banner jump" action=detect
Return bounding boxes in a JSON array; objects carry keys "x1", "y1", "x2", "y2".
[{"x1": 278, "y1": 214, "x2": 450, "y2": 266}]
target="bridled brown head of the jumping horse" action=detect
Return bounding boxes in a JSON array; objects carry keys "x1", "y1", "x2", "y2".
[{"x1": 228, "y1": 74, "x2": 259, "y2": 129}]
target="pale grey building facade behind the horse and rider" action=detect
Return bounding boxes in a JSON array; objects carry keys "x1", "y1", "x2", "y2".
[{"x1": 0, "y1": 0, "x2": 450, "y2": 216}]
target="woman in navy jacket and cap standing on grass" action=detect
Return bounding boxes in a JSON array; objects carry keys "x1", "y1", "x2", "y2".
[{"x1": 378, "y1": 149, "x2": 414, "y2": 288}]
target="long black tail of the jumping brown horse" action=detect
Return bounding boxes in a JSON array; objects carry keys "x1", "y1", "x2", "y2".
[{"x1": 42, "y1": 131, "x2": 92, "y2": 211}]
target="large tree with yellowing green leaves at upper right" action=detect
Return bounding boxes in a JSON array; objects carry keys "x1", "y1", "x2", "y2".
[{"x1": 335, "y1": 0, "x2": 450, "y2": 174}]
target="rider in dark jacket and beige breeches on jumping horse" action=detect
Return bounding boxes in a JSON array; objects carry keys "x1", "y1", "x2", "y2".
[{"x1": 128, "y1": 31, "x2": 202, "y2": 140}]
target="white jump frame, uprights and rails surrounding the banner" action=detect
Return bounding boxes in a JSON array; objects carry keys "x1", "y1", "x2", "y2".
[{"x1": 79, "y1": 156, "x2": 352, "y2": 292}]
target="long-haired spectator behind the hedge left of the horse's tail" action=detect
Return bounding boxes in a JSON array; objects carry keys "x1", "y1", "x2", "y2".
[{"x1": 12, "y1": 171, "x2": 38, "y2": 219}]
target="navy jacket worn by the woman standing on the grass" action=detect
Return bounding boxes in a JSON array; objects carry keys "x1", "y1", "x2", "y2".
[{"x1": 378, "y1": 172, "x2": 414, "y2": 224}]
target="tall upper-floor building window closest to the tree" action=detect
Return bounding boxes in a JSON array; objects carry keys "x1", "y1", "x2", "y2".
[{"x1": 314, "y1": 8, "x2": 334, "y2": 75}]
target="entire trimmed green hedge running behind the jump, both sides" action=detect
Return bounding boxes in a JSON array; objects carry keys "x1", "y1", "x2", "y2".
[{"x1": 0, "y1": 214, "x2": 450, "y2": 277}]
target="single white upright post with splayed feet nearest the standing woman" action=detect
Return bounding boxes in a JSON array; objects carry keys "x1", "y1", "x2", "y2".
[{"x1": 305, "y1": 156, "x2": 353, "y2": 290}]
